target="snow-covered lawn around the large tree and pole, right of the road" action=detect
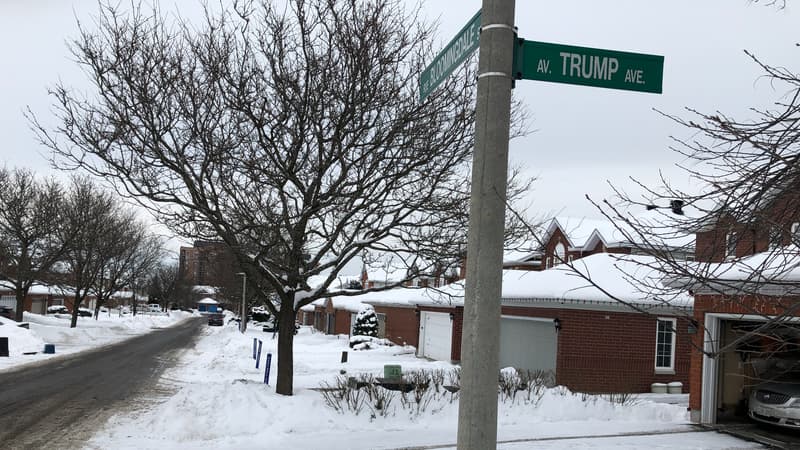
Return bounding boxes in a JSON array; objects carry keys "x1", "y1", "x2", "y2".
[{"x1": 88, "y1": 324, "x2": 760, "y2": 450}]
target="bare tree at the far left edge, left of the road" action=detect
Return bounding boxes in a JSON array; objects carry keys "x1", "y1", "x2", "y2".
[{"x1": 0, "y1": 168, "x2": 70, "y2": 321}]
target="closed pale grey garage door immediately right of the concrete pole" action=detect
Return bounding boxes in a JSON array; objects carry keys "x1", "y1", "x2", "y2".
[{"x1": 500, "y1": 316, "x2": 558, "y2": 371}]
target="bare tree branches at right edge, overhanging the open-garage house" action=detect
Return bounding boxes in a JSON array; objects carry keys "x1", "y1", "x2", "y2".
[{"x1": 568, "y1": 43, "x2": 800, "y2": 394}]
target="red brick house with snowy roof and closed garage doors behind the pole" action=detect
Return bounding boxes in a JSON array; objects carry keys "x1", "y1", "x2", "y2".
[{"x1": 416, "y1": 254, "x2": 694, "y2": 392}]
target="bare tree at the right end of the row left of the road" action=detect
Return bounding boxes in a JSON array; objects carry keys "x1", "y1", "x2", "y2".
[{"x1": 92, "y1": 211, "x2": 164, "y2": 318}]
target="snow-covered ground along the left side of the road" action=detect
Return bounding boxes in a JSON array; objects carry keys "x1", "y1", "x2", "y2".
[{"x1": 0, "y1": 310, "x2": 191, "y2": 371}]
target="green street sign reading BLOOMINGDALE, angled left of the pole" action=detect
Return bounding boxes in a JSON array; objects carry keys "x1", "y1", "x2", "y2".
[{"x1": 419, "y1": 11, "x2": 481, "y2": 101}]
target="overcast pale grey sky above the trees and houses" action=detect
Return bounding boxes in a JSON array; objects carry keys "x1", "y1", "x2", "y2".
[{"x1": 0, "y1": 0, "x2": 800, "y2": 217}]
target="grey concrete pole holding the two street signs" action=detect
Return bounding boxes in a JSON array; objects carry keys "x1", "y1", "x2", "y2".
[{"x1": 458, "y1": 0, "x2": 515, "y2": 450}]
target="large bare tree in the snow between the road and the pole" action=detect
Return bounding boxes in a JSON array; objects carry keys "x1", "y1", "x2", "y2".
[{"x1": 33, "y1": 0, "x2": 536, "y2": 395}]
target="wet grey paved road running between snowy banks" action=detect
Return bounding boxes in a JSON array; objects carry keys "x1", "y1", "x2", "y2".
[{"x1": 0, "y1": 319, "x2": 205, "y2": 449}]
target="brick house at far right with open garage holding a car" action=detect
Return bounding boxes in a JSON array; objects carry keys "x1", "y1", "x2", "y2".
[{"x1": 682, "y1": 191, "x2": 800, "y2": 424}]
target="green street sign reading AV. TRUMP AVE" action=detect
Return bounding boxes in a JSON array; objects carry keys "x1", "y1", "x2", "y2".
[{"x1": 514, "y1": 39, "x2": 664, "y2": 94}]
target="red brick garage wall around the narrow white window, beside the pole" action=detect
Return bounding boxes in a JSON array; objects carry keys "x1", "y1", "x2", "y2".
[{"x1": 453, "y1": 306, "x2": 691, "y2": 392}]
